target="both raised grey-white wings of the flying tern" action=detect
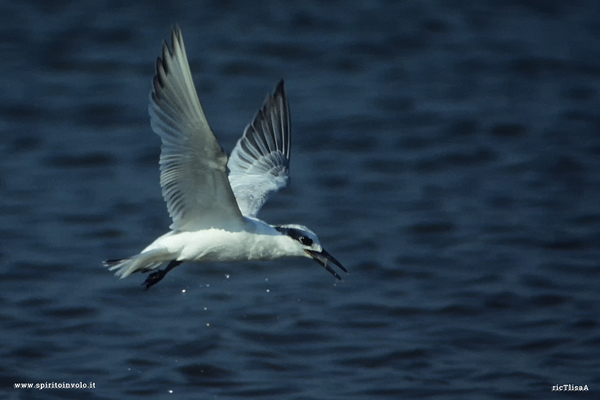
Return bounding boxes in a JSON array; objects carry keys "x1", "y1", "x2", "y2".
[{"x1": 149, "y1": 27, "x2": 291, "y2": 230}]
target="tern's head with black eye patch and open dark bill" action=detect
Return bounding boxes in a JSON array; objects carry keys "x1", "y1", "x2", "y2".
[{"x1": 275, "y1": 225, "x2": 348, "y2": 281}]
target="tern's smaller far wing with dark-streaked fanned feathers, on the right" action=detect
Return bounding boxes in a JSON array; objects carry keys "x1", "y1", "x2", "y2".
[{"x1": 227, "y1": 80, "x2": 291, "y2": 217}]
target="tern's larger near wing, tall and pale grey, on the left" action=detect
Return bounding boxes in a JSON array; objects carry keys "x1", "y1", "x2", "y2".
[{"x1": 149, "y1": 27, "x2": 244, "y2": 231}]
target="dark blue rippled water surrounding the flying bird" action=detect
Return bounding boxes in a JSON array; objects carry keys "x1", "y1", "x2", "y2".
[{"x1": 0, "y1": 0, "x2": 600, "y2": 400}]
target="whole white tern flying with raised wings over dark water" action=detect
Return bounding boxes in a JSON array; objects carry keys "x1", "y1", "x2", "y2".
[{"x1": 104, "y1": 27, "x2": 348, "y2": 289}]
